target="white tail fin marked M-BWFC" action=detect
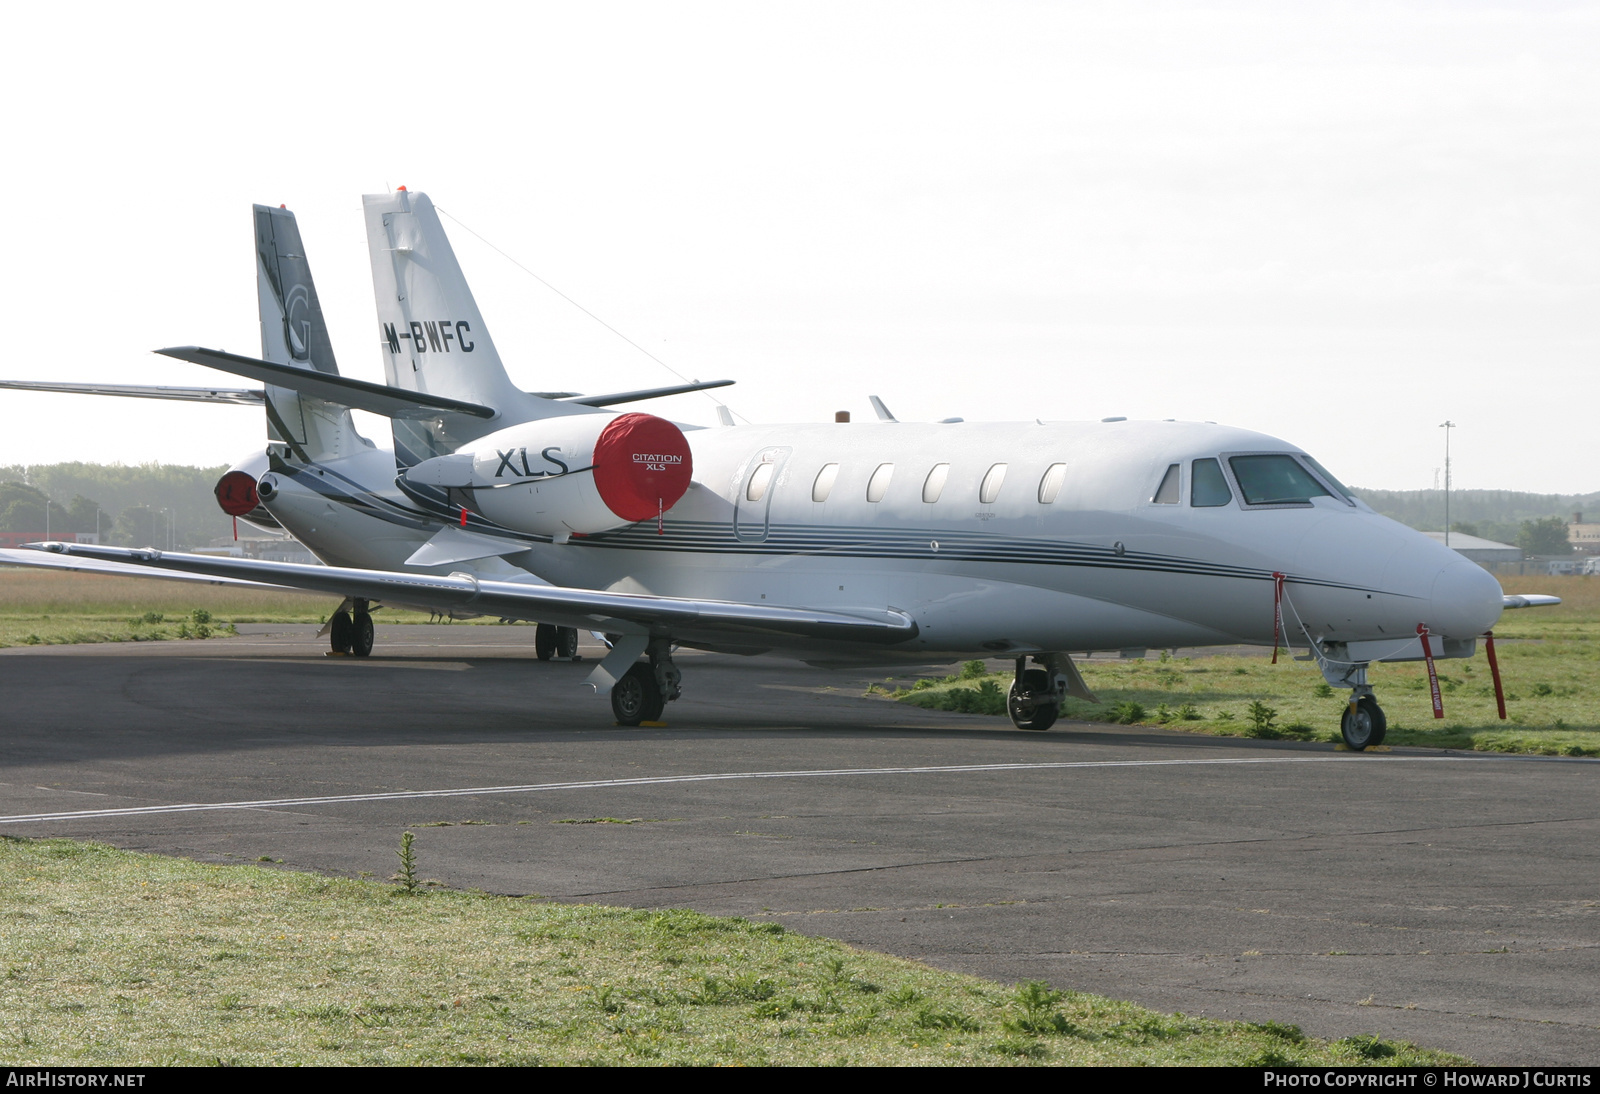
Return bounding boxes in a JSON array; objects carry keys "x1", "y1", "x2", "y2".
[{"x1": 362, "y1": 190, "x2": 595, "y2": 469}]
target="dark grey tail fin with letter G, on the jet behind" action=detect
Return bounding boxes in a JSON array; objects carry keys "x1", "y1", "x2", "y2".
[{"x1": 254, "y1": 205, "x2": 368, "y2": 462}]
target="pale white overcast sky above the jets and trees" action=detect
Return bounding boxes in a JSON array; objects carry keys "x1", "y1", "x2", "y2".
[{"x1": 0, "y1": 0, "x2": 1600, "y2": 493}]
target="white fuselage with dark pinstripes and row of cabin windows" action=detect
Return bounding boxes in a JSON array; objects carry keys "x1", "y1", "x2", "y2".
[{"x1": 246, "y1": 421, "x2": 1502, "y2": 657}]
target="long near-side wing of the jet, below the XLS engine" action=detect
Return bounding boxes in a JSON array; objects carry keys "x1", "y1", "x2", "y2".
[{"x1": 16, "y1": 544, "x2": 917, "y2": 646}]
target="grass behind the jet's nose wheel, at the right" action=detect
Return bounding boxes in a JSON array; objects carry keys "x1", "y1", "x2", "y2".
[{"x1": 878, "y1": 577, "x2": 1600, "y2": 757}]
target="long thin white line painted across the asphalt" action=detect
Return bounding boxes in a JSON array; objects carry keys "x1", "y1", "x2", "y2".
[{"x1": 0, "y1": 757, "x2": 1482, "y2": 824}]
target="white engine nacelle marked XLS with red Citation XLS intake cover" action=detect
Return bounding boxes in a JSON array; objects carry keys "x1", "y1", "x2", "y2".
[{"x1": 405, "y1": 413, "x2": 694, "y2": 536}]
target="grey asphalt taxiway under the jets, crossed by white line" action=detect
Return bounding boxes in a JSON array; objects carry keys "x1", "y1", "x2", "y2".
[{"x1": 0, "y1": 625, "x2": 1600, "y2": 1064}]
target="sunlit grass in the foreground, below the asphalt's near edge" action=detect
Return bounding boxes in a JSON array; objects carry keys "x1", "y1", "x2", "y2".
[{"x1": 0, "y1": 838, "x2": 1464, "y2": 1067}]
